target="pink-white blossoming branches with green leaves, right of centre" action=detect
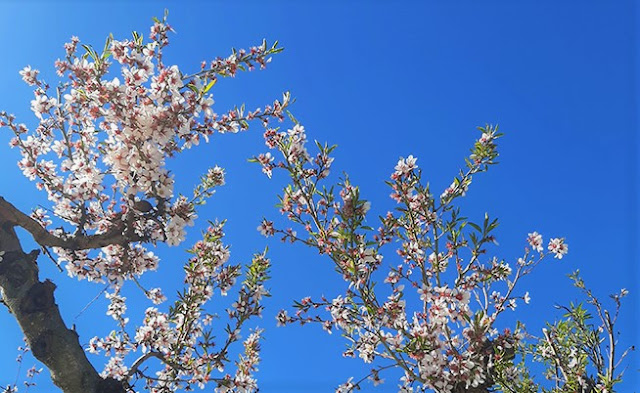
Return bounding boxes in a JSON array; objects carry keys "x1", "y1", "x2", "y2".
[{"x1": 253, "y1": 119, "x2": 604, "y2": 392}]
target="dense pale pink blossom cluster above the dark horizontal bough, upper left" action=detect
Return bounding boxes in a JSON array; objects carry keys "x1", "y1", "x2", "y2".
[{"x1": 0, "y1": 15, "x2": 289, "y2": 288}]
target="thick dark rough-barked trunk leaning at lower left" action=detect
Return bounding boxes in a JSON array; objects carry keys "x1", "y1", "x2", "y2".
[{"x1": 0, "y1": 201, "x2": 126, "y2": 393}]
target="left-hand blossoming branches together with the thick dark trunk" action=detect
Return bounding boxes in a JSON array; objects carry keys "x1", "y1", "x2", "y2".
[{"x1": 0, "y1": 15, "x2": 289, "y2": 392}]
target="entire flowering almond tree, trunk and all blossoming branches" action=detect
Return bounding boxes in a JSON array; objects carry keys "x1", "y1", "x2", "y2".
[{"x1": 0, "y1": 15, "x2": 625, "y2": 393}]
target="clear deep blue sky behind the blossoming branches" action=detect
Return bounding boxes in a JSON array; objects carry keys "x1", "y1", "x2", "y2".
[{"x1": 0, "y1": 1, "x2": 640, "y2": 393}]
